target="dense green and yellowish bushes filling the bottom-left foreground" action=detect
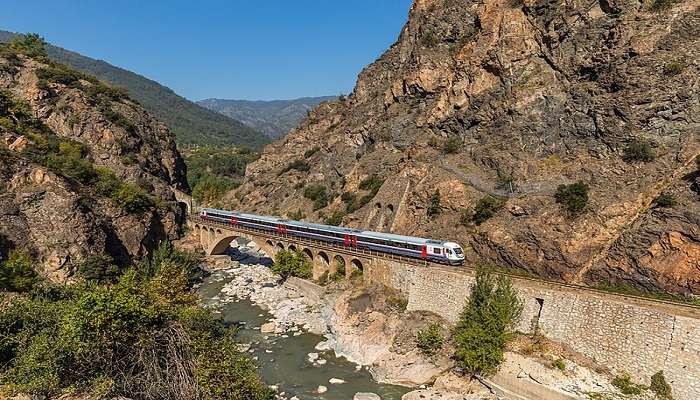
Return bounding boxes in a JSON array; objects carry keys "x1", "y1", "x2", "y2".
[{"x1": 0, "y1": 245, "x2": 273, "y2": 400}]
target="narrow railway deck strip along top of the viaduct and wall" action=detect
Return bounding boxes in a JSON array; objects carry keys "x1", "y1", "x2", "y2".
[{"x1": 190, "y1": 216, "x2": 700, "y2": 318}]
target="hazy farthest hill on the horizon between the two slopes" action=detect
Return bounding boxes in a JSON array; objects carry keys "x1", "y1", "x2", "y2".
[{"x1": 197, "y1": 96, "x2": 336, "y2": 139}]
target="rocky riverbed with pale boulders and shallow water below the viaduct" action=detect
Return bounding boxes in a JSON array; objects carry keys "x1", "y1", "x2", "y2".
[{"x1": 197, "y1": 247, "x2": 644, "y2": 400}]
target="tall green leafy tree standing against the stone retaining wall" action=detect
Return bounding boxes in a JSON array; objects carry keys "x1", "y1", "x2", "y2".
[{"x1": 453, "y1": 268, "x2": 523, "y2": 375}]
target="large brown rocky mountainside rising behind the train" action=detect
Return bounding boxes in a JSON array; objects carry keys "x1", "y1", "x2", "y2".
[{"x1": 231, "y1": 0, "x2": 700, "y2": 293}]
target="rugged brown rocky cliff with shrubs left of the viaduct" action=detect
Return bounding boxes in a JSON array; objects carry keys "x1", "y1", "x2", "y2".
[{"x1": 0, "y1": 48, "x2": 188, "y2": 282}]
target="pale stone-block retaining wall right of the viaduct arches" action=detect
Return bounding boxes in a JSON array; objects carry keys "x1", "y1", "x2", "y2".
[{"x1": 366, "y1": 260, "x2": 700, "y2": 400}]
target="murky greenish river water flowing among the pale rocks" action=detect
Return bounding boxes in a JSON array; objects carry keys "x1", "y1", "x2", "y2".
[{"x1": 199, "y1": 271, "x2": 411, "y2": 400}]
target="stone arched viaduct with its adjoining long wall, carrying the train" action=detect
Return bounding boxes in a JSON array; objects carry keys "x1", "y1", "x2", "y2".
[{"x1": 190, "y1": 217, "x2": 700, "y2": 400}]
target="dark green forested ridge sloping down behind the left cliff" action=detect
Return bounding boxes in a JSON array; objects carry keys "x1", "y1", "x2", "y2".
[{"x1": 0, "y1": 31, "x2": 269, "y2": 149}]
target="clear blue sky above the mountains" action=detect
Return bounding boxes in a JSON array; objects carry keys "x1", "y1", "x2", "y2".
[{"x1": 0, "y1": 0, "x2": 411, "y2": 100}]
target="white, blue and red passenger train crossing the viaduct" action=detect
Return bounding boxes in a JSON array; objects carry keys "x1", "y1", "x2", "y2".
[{"x1": 199, "y1": 208, "x2": 464, "y2": 265}]
